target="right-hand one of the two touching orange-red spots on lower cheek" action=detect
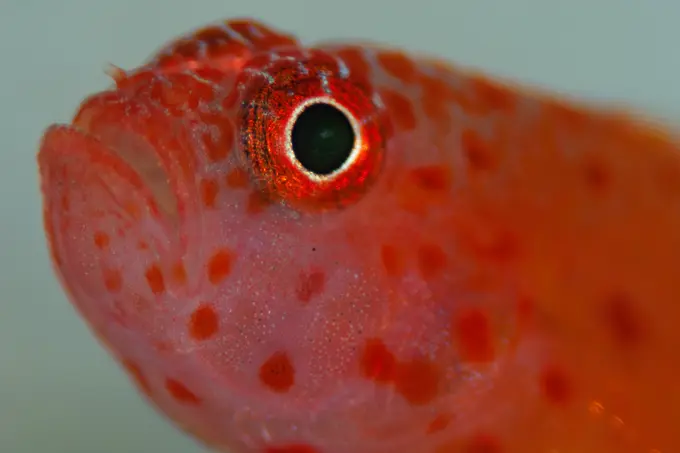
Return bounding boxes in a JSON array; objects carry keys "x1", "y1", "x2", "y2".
[{"x1": 394, "y1": 357, "x2": 440, "y2": 406}]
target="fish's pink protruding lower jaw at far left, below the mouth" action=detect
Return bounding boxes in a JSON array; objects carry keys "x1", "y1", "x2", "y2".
[{"x1": 38, "y1": 123, "x2": 173, "y2": 342}]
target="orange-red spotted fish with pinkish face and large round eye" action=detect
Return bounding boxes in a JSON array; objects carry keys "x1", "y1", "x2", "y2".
[{"x1": 37, "y1": 17, "x2": 680, "y2": 453}]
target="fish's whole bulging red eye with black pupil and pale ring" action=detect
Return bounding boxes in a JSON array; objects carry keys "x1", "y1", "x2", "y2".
[{"x1": 239, "y1": 51, "x2": 392, "y2": 211}]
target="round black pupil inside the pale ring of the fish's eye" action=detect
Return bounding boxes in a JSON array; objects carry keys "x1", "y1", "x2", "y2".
[{"x1": 291, "y1": 103, "x2": 354, "y2": 175}]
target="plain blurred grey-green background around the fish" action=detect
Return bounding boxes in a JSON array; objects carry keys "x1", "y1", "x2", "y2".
[{"x1": 0, "y1": 0, "x2": 680, "y2": 453}]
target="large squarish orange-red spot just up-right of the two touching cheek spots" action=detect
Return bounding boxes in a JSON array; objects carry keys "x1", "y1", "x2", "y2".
[{"x1": 451, "y1": 308, "x2": 494, "y2": 362}]
